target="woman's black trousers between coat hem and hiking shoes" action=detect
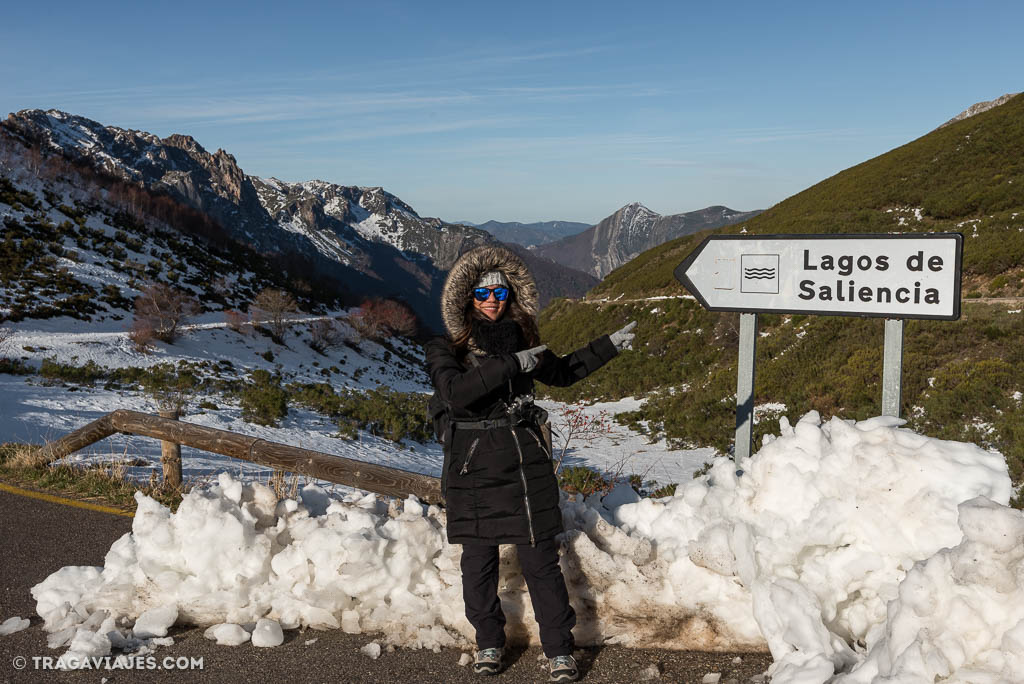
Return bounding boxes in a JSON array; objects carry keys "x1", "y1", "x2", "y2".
[{"x1": 462, "y1": 539, "x2": 575, "y2": 657}]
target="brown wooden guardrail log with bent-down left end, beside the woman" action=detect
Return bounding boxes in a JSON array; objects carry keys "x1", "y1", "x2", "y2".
[{"x1": 38, "y1": 410, "x2": 443, "y2": 504}]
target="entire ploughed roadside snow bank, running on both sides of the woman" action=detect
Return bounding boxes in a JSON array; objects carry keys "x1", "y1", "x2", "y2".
[{"x1": 33, "y1": 413, "x2": 1024, "y2": 684}]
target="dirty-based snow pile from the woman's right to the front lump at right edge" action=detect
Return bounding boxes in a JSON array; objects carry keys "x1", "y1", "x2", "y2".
[{"x1": 563, "y1": 412, "x2": 1011, "y2": 663}]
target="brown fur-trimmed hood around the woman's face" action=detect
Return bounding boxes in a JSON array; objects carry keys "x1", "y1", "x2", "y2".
[{"x1": 441, "y1": 247, "x2": 540, "y2": 349}]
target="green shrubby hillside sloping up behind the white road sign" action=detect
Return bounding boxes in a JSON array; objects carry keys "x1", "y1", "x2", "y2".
[{"x1": 541, "y1": 96, "x2": 1024, "y2": 505}]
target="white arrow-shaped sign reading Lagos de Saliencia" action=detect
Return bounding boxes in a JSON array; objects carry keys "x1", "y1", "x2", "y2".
[{"x1": 675, "y1": 232, "x2": 964, "y2": 320}]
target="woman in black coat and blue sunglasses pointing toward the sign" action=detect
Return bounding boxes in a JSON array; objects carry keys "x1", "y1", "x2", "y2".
[{"x1": 426, "y1": 247, "x2": 636, "y2": 682}]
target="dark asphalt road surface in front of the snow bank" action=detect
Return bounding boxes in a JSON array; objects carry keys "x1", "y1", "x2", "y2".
[{"x1": 0, "y1": 483, "x2": 771, "y2": 684}]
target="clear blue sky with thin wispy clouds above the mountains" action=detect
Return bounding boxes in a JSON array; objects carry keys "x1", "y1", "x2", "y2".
[{"x1": 0, "y1": 0, "x2": 1024, "y2": 222}]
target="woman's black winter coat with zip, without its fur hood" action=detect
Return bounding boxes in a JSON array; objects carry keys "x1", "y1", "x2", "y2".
[{"x1": 426, "y1": 335, "x2": 617, "y2": 545}]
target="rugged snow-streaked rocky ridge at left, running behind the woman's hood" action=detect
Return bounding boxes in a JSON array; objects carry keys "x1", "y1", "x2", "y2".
[{"x1": 0, "y1": 110, "x2": 596, "y2": 330}]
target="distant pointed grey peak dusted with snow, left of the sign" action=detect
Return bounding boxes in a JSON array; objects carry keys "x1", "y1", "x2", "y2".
[{"x1": 534, "y1": 202, "x2": 761, "y2": 279}]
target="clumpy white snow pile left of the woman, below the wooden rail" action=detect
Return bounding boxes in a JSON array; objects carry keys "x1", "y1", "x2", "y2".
[{"x1": 32, "y1": 473, "x2": 470, "y2": 667}]
